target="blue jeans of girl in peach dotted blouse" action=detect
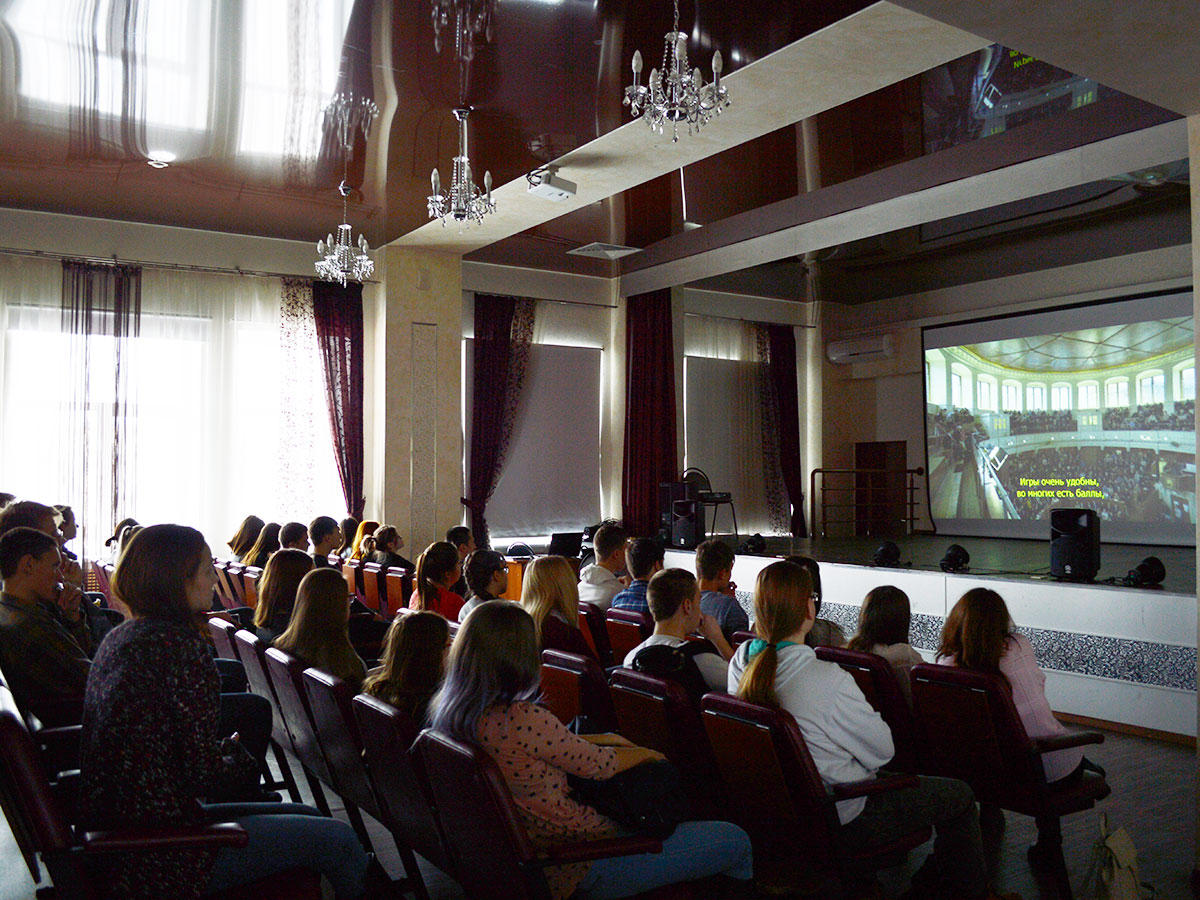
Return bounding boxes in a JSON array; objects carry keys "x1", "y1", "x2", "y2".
[{"x1": 575, "y1": 822, "x2": 754, "y2": 900}]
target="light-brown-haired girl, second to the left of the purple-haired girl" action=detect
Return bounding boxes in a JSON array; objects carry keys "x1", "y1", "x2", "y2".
[{"x1": 274, "y1": 569, "x2": 367, "y2": 694}]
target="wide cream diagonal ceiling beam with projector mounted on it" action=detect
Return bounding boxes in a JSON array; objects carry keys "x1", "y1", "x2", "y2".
[{"x1": 394, "y1": 1, "x2": 991, "y2": 253}]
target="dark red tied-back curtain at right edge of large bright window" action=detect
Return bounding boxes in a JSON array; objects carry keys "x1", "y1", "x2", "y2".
[{"x1": 312, "y1": 281, "x2": 366, "y2": 518}]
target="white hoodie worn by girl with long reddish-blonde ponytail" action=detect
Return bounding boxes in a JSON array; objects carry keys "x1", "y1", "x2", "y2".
[{"x1": 728, "y1": 641, "x2": 895, "y2": 824}]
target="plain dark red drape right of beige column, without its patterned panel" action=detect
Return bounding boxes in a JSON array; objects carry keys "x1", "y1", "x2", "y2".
[{"x1": 463, "y1": 300, "x2": 517, "y2": 547}]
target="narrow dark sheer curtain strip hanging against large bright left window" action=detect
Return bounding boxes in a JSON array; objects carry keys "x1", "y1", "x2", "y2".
[{"x1": 62, "y1": 260, "x2": 142, "y2": 556}]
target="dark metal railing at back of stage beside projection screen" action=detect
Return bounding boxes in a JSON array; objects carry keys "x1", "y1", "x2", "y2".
[{"x1": 809, "y1": 466, "x2": 925, "y2": 538}]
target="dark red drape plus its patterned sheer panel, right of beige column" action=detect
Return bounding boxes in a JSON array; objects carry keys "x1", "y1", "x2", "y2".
[{"x1": 462, "y1": 294, "x2": 535, "y2": 547}]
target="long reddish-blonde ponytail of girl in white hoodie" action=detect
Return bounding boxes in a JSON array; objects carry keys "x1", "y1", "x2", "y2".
[{"x1": 738, "y1": 560, "x2": 812, "y2": 707}]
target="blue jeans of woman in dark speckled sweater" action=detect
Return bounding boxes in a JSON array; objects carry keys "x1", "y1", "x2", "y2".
[{"x1": 204, "y1": 803, "x2": 367, "y2": 900}]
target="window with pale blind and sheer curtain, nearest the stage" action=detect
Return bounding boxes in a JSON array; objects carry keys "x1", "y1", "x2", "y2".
[{"x1": 684, "y1": 314, "x2": 775, "y2": 535}]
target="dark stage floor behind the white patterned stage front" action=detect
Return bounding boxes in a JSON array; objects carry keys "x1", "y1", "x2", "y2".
[{"x1": 742, "y1": 534, "x2": 1196, "y2": 594}]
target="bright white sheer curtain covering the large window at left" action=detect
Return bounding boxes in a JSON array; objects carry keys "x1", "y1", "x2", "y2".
[{"x1": 0, "y1": 257, "x2": 346, "y2": 556}]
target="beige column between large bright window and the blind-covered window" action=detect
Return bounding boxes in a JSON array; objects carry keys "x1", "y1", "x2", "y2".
[{"x1": 366, "y1": 246, "x2": 463, "y2": 559}]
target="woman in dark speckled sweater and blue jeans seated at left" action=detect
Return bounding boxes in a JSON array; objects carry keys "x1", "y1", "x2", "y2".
[{"x1": 79, "y1": 524, "x2": 368, "y2": 900}]
